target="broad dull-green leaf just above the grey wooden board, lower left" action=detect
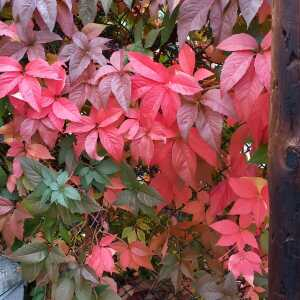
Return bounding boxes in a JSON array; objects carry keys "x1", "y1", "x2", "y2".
[{"x1": 11, "y1": 242, "x2": 48, "y2": 264}]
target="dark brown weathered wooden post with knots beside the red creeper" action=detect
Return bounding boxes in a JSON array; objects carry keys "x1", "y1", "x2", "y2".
[{"x1": 268, "y1": 0, "x2": 300, "y2": 300}]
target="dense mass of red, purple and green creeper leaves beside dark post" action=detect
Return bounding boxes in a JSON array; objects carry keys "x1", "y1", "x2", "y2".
[{"x1": 0, "y1": 0, "x2": 271, "y2": 300}]
